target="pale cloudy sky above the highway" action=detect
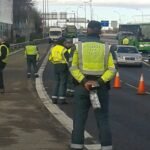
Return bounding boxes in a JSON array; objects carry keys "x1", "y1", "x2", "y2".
[{"x1": 34, "y1": 0, "x2": 150, "y2": 23}]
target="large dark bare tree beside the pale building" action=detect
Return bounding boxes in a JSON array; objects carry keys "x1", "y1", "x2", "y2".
[{"x1": 13, "y1": 0, "x2": 42, "y2": 41}]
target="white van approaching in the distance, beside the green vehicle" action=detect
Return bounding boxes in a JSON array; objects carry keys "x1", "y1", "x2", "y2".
[{"x1": 49, "y1": 27, "x2": 62, "y2": 43}]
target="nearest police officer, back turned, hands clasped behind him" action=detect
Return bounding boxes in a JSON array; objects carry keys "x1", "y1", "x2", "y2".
[{"x1": 70, "y1": 21, "x2": 116, "y2": 150}]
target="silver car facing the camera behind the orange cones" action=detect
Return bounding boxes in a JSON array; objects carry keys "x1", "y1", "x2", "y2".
[{"x1": 116, "y1": 45, "x2": 142, "y2": 67}]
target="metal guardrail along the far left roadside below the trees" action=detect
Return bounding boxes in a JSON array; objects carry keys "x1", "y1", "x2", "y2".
[{"x1": 10, "y1": 38, "x2": 48, "y2": 52}]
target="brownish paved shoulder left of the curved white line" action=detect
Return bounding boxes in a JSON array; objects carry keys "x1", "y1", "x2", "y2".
[{"x1": 0, "y1": 44, "x2": 70, "y2": 150}]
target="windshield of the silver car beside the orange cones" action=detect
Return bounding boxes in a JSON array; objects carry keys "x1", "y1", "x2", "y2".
[{"x1": 117, "y1": 47, "x2": 138, "y2": 53}]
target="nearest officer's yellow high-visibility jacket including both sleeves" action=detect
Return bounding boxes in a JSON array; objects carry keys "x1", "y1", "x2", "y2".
[{"x1": 70, "y1": 42, "x2": 116, "y2": 82}]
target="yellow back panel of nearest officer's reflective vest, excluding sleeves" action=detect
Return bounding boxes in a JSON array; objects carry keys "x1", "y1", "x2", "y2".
[{"x1": 78, "y1": 42, "x2": 109, "y2": 75}]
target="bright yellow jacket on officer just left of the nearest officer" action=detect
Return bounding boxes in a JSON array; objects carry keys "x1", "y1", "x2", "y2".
[{"x1": 49, "y1": 45, "x2": 67, "y2": 64}]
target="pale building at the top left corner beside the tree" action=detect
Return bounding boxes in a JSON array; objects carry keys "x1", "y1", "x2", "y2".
[{"x1": 0, "y1": 0, "x2": 13, "y2": 38}]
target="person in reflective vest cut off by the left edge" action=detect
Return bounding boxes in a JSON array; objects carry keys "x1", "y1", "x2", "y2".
[{"x1": 0, "y1": 37, "x2": 9, "y2": 93}]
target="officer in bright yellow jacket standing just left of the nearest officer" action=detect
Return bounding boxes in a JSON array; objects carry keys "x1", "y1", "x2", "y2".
[{"x1": 49, "y1": 37, "x2": 68, "y2": 104}]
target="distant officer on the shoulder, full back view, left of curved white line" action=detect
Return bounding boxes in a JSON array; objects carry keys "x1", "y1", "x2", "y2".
[{"x1": 25, "y1": 42, "x2": 39, "y2": 78}]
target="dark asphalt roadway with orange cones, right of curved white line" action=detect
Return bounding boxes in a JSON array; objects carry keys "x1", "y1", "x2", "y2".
[{"x1": 43, "y1": 39, "x2": 150, "y2": 150}]
